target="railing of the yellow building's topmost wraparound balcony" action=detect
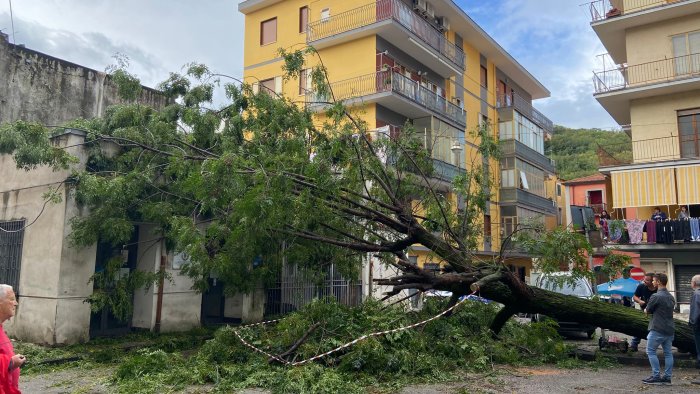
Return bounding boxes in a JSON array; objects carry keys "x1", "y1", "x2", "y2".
[{"x1": 306, "y1": 0, "x2": 465, "y2": 70}]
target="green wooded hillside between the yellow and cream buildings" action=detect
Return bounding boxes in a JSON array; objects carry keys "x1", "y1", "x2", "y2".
[{"x1": 545, "y1": 125, "x2": 632, "y2": 180}]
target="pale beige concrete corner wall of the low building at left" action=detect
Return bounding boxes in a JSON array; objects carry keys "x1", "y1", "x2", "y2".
[{"x1": 0, "y1": 132, "x2": 95, "y2": 344}]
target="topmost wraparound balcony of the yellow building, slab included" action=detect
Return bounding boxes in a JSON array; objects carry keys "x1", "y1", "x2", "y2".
[{"x1": 306, "y1": 0, "x2": 466, "y2": 78}]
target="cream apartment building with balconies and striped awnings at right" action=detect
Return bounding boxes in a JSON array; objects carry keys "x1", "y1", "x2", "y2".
[{"x1": 590, "y1": 0, "x2": 700, "y2": 304}]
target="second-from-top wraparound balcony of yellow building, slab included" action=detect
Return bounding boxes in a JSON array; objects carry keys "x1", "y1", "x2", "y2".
[{"x1": 306, "y1": 70, "x2": 467, "y2": 129}]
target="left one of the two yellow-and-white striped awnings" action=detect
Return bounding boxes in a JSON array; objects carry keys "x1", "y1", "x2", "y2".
[{"x1": 610, "y1": 167, "x2": 676, "y2": 208}]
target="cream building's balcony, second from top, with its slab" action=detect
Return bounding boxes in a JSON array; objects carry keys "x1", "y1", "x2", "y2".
[{"x1": 593, "y1": 53, "x2": 700, "y2": 124}]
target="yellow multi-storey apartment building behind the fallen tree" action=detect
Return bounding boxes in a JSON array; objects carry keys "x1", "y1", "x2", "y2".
[{"x1": 238, "y1": 0, "x2": 561, "y2": 290}]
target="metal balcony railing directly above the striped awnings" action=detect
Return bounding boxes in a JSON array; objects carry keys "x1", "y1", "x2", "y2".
[{"x1": 598, "y1": 135, "x2": 700, "y2": 166}]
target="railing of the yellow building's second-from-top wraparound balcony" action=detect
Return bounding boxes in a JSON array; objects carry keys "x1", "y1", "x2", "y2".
[{"x1": 306, "y1": 70, "x2": 467, "y2": 127}]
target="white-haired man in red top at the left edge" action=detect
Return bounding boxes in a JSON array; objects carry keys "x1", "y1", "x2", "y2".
[{"x1": 0, "y1": 285, "x2": 25, "y2": 394}]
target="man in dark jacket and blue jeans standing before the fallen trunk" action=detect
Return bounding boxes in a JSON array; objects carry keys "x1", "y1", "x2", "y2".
[{"x1": 642, "y1": 274, "x2": 676, "y2": 384}]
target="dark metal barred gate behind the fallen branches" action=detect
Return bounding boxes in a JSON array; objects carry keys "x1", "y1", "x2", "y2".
[{"x1": 265, "y1": 264, "x2": 362, "y2": 317}]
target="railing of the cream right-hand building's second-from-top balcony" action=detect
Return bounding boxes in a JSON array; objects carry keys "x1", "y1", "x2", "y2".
[{"x1": 593, "y1": 53, "x2": 700, "y2": 93}]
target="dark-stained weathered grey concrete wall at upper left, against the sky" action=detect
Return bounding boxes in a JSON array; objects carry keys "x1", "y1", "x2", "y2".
[{"x1": 0, "y1": 33, "x2": 166, "y2": 125}]
